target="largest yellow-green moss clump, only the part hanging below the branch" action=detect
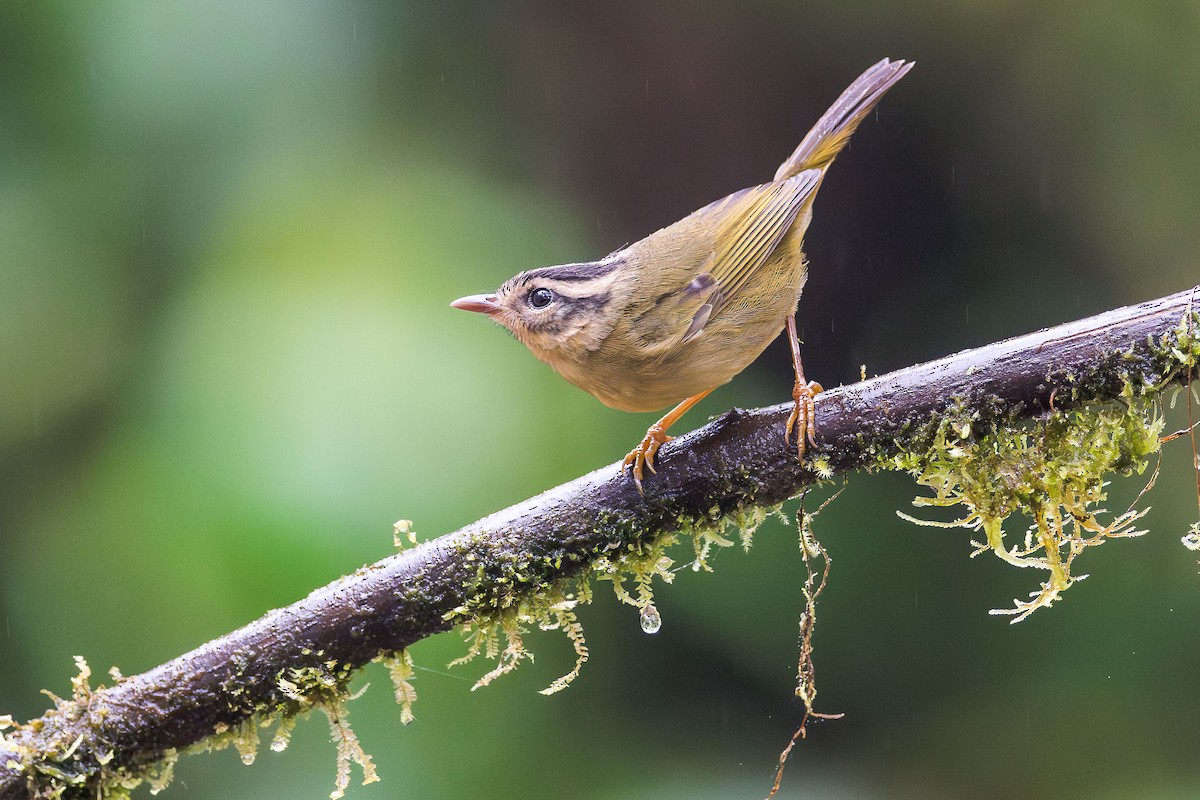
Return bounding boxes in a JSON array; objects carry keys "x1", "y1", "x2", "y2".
[{"x1": 895, "y1": 398, "x2": 1163, "y2": 622}]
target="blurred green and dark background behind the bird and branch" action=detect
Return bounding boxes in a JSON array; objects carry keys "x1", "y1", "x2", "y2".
[{"x1": 0, "y1": 0, "x2": 1200, "y2": 799}]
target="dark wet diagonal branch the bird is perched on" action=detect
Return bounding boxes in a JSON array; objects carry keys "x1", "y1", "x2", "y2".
[{"x1": 0, "y1": 287, "x2": 1200, "y2": 800}]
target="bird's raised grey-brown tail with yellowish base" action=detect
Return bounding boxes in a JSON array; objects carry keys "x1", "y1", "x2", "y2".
[{"x1": 775, "y1": 59, "x2": 913, "y2": 181}]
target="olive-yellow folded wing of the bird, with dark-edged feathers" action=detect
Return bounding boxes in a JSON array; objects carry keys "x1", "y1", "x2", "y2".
[{"x1": 689, "y1": 169, "x2": 821, "y2": 321}]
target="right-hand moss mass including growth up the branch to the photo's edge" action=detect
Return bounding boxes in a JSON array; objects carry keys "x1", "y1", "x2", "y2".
[{"x1": 888, "y1": 314, "x2": 1200, "y2": 622}]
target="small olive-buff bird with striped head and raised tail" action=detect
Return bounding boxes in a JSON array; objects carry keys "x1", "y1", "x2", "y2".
[{"x1": 450, "y1": 59, "x2": 912, "y2": 492}]
